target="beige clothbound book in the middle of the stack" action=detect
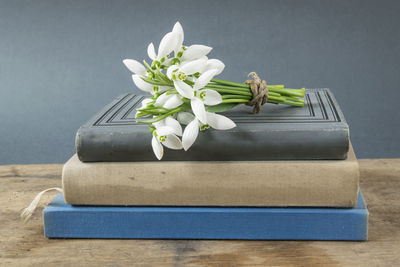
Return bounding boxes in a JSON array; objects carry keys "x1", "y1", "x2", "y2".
[{"x1": 62, "y1": 144, "x2": 359, "y2": 207}]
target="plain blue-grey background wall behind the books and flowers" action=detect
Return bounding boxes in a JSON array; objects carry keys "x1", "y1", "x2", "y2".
[{"x1": 0, "y1": 0, "x2": 400, "y2": 164}]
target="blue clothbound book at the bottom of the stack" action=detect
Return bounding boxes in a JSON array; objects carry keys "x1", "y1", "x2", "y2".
[{"x1": 43, "y1": 192, "x2": 368, "y2": 240}]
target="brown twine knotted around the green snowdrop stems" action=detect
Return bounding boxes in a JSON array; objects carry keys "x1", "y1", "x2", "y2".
[{"x1": 244, "y1": 71, "x2": 268, "y2": 114}]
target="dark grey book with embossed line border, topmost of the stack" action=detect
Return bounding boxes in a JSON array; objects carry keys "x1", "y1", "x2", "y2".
[{"x1": 76, "y1": 89, "x2": 349, "y2": 162}]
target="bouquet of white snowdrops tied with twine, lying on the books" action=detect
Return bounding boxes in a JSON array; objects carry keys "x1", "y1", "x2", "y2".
[{"x1": 123, "y1": 22, "x2": 305, "y2": 160}]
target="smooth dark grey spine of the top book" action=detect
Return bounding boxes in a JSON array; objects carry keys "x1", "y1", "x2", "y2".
[{"x1": 76, "y1": 123, "x2": 349, "y2": 162}]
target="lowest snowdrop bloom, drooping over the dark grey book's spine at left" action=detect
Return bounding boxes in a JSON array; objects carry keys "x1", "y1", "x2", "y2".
[{"x1": 151, "y1": 117, "x2": 182, "y2": 160}]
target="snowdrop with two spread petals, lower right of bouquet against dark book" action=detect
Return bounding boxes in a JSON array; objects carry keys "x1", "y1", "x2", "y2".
[{"x1": 178, "y1": 112, "x2": 236, "y2": 151}]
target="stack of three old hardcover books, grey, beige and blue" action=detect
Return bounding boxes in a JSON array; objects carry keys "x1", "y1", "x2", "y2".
[{"x1": 44, "y1": 89, "x2": 368, "y2": 240}]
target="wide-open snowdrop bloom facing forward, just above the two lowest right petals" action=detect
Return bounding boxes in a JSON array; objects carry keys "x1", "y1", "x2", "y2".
[{"x1": 167, "y1": 68, "x2": 222, "y2": 124}]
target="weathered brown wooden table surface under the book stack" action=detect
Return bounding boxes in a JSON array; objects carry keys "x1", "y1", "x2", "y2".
[{"x1": 0, "y1": 159, "x2": 400, "y2": 266}]
